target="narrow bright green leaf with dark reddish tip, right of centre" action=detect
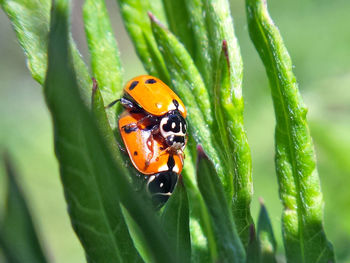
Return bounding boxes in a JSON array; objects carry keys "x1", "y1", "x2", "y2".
[{"x1": 214, "y1": 40, "x2": 253, "y2": 250}]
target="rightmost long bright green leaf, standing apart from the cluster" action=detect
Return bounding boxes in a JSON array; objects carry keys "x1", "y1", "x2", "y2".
[{"x1": 246, "y1": 0, "x2": 334, "y2": 262}]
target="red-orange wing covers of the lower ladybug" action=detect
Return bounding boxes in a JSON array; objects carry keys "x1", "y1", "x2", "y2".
[{"x1": 119, "y1": 111, "x2": 183, "y2": 175}]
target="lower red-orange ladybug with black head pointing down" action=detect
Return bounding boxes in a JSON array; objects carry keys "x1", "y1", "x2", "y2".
[{"x1": 118, "y1": 111, "x2": 183, "y2": 204}]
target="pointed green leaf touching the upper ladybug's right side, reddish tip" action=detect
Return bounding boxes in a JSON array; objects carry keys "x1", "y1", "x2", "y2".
[{"x1": 150, "y1": 15, "x2": 226, "y2": 194}]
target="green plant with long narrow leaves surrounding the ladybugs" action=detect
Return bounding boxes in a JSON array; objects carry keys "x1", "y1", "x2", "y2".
[{"x1": 0, "y1": 0, "x2": 334, "y2": 262}]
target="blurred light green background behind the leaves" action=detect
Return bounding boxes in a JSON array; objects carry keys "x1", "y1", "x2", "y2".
[{"x1": 0, "y1": 0, "x2": 350, "y2": 263}]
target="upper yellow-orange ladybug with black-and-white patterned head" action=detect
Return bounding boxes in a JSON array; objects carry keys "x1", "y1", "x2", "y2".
[{"x1": 113, "y1": 75, "x2": 187, "y2": 154}]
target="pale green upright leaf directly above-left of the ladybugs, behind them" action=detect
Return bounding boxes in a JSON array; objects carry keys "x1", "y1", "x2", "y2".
[{"x1": 83, "y1": 0, "x2": 123, "y2": 128}]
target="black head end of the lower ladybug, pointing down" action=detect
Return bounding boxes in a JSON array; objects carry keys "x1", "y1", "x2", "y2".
[{"x1": 147, "y1": 171, "x2": 178, "y2": 206}]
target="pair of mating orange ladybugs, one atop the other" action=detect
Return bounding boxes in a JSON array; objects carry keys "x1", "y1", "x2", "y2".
[{"x1": 112, "y1": 75, "x2": 187, "y2": 204}]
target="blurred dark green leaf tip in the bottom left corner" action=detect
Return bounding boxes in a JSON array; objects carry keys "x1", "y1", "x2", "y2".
[{"x1": 0, "y1": 155, "x2": 47, "y2": 263}]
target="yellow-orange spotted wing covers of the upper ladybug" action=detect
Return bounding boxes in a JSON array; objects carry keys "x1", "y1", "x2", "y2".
[{"x1": 124, "y1": 75, "x2": 187, "y2": 118}]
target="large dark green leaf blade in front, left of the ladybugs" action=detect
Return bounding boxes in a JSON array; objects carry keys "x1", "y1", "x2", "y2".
[{"x1": 44, "y1": 1, "x2": 138, "y2": 262}]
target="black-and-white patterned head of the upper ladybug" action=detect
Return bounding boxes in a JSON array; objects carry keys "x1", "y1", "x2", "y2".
[{"x1": 159, "y1": 111, "x2": 187, "y2": 150}]
